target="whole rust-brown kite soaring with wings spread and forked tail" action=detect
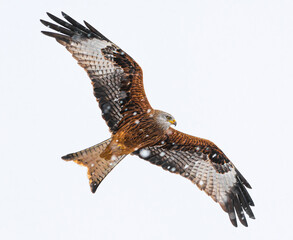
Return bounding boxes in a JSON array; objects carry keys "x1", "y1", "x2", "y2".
[{"x1": 41, "y1": 12, "x2": 255, "y2": 227}]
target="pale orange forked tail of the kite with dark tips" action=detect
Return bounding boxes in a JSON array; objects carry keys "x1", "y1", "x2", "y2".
[{"x1": 62, "y1": 138, "x2": 125, "y2": 193}]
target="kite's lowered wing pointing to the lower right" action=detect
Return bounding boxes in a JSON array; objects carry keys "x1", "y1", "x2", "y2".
[{"x1": 133, "y1": 128, "x2": 254, "y2": 227}]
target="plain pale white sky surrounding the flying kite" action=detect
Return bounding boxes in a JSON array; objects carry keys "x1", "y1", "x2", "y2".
[{"x1": 0, "y1": 0, "x2": 293, "y2": 240}]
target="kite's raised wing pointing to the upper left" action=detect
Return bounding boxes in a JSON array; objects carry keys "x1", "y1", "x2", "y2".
[{"x1": 41, "y1": 12, "x2": 151, "y2": 133}]
